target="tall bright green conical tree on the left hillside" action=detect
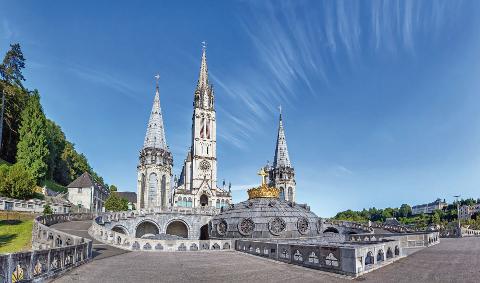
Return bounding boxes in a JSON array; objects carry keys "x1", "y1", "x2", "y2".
[{"x1": 17, "y1": 91, "x2": 49, "y2": 184}]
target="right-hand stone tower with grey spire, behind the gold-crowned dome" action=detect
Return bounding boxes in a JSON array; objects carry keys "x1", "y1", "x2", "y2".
[{"x1": 267, "y1": 112, "x2": 296, "y2": 202}]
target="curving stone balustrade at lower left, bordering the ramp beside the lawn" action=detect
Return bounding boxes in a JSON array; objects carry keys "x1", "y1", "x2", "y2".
[{"x1": 0, "y1": 214, "x2": 93, "y2": 282}]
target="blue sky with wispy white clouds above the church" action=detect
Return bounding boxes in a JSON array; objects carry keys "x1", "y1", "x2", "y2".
[{"x1": 0, "y1": 1, "x2": 480, "y2": 216}]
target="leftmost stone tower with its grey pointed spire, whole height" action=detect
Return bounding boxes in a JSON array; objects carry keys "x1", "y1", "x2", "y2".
[{"x1": 137, "y1": 79, "x2": 173, "y2": 209}]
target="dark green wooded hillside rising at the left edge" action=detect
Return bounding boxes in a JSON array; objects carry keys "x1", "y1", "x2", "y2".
[{"x1": 0, "y1": 43, "x2": 104, "y2": 198}]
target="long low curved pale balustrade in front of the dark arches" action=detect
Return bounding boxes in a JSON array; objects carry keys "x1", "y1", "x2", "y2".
[{"x1": 88, "y1": 214, "x2": 235, "y2": 252}]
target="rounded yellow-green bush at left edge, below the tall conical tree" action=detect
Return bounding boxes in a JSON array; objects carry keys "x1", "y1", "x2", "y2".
[{"x1": 0, "y1": 163, "x2": 35, "y2": 199}]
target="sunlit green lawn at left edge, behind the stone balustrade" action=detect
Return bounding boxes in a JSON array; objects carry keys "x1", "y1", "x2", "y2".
[{"x1": 0, "y1": 219, "x2": 33, "y2": 254}]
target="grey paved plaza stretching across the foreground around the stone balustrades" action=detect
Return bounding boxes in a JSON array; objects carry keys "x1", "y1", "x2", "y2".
[{"x1": 53, "y1": 221, "x2": 480, "y2": 283}]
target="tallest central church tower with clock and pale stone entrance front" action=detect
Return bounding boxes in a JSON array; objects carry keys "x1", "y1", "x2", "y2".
[{"x1": 172, "y1": 46, "x2": 232, "y2": 208}]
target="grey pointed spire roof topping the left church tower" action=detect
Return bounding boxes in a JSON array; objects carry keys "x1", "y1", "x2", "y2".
[{"x1": 143, "y1": 75, "x2": 168, "y2": 150}]
